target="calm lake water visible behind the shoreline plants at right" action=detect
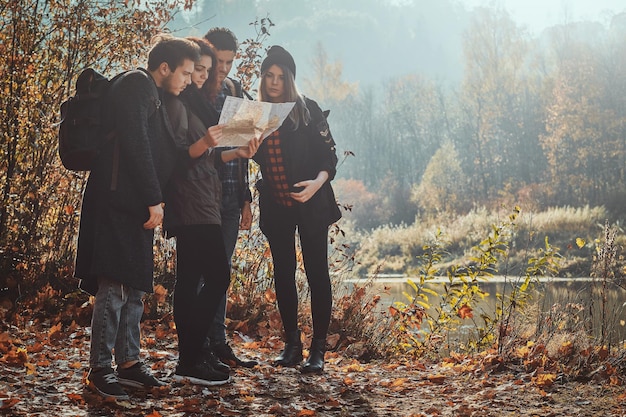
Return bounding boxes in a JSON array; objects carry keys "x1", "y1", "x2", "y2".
[{"x1": 338, "y1": 276, "x2": 626, "y2": 342}]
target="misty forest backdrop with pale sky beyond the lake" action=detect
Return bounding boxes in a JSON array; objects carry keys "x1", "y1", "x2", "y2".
[{"x1": 166, "y1": 0, "x2": 626, "y2": 276}]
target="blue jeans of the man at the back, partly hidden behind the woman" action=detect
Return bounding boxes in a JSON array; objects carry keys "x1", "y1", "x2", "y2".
[{"x1": 209, "y1": 193, "x2": 241, "y2": 345}]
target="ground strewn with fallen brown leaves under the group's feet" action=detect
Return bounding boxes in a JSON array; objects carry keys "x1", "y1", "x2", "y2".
[{"x1": 0, "y1": 316, "x2": 626, "y2": 417}]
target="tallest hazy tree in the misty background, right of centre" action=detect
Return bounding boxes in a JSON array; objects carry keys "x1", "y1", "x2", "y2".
[{"x1": 457, "y1": 9, "x2": 540, "y2": 201}]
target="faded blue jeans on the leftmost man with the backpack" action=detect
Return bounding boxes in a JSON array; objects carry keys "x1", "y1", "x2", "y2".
[{"x1": 89, "y1": 278, "x2": 145, "y2": 368}]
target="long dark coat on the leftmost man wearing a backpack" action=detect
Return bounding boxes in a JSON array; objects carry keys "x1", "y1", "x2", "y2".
[{"x1": 74, "y1": 69, "x2": 176, "y2": 294}]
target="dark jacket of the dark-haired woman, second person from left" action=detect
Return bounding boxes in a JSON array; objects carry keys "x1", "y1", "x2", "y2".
[{"x1": 163, "y1": 84, "x2": 222, "y2": 236}]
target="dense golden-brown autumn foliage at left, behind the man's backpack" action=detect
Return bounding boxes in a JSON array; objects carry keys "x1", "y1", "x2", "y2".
[{"x1": 0, "y1": 0, "x2": 190, "y2": 306}]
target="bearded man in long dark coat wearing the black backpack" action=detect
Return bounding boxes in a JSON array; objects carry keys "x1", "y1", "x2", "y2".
[{"x1": 75, "y1": 35, "x2": 199, "y2": 399}]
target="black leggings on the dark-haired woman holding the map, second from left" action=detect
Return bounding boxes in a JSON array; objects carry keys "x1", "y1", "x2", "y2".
[{"x1": 174, "y1": 224, "x2": 230, "y2": 364}]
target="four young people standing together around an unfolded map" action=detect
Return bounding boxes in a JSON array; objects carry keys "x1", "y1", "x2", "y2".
[{"x1": 75, "y1": 28, "x2": 341, "y2": 399}]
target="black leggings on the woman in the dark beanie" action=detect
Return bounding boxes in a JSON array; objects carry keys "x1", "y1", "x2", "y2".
[{"x1": 264, "y1": 209, "x2": 333, "y2": 339}]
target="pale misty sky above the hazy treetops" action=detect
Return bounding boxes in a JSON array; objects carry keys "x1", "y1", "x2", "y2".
[{"x1": 174, "y1": 0, "x2": 626, "y2": 86}]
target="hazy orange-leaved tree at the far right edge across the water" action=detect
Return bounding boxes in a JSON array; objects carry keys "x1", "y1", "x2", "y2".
[{"x1": 541, "y1": 22, "x2": 626, "y2": 205}]
